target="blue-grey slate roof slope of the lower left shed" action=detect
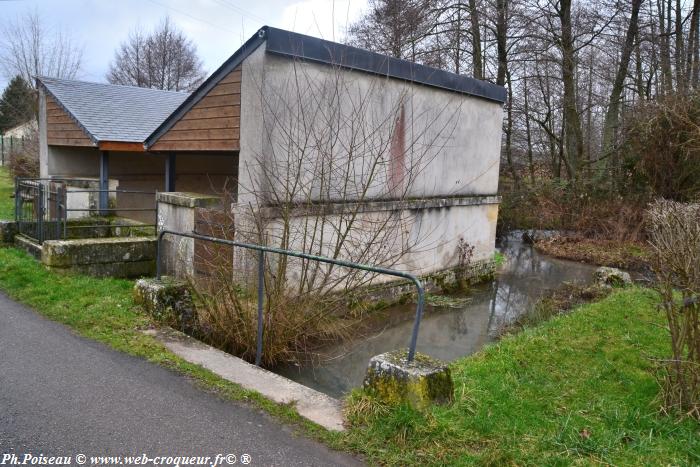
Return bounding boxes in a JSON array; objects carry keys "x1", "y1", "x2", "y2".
[{"x1": 37, "y1": 77, "x2": 189, "y2": 143}]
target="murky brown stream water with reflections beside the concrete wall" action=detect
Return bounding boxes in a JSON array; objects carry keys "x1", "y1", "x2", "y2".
[{"x1": 276, "y1": 239, "x2": 595, "y2": 397}]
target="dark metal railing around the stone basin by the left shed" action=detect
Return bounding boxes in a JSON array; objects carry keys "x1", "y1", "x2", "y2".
[{"x1": 15, "y1": 177, "x2": 157, "y2": 243}]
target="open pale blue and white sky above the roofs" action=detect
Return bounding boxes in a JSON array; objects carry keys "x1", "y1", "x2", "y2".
[{"x1": 0, "y1": 0, "x2": 367, "y2": 90}]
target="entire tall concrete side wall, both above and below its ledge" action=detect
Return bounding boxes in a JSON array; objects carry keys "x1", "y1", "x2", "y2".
[{"x1": 234, "y1": 47, "x2": 503, "y2": 282}]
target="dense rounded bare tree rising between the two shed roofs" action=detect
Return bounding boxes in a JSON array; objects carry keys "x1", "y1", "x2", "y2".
[{"x1": 107, "y1": 17, "x2": 206, "y2": 91}]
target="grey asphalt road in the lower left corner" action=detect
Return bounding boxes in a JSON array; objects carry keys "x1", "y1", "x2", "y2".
[{"x1": 0, "y1": 294, "x2": 359, "y2": 466}]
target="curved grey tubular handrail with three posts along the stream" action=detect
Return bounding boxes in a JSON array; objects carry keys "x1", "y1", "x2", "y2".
[{"x1": 156, "y1": 229, "x2": 425, "y2": 366}]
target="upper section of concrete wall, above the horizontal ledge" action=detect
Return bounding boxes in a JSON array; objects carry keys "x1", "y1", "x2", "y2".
[{"x1": 241, "y1": 48, "x2": 503, "y2": 206}]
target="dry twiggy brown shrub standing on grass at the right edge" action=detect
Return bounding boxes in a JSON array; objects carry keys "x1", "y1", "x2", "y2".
[{"x1": 649, "y1": 200, "x2": 700, "y2": 420}]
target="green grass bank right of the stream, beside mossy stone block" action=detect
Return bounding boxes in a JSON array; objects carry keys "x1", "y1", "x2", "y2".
[{"x1": 349, "y1": 288, "x2": 700, "y2": 465}]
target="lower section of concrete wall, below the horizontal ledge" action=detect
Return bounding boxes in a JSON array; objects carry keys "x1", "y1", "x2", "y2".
[{"x1": 266, "y1": 197, "x2": 498, "y2": 282}]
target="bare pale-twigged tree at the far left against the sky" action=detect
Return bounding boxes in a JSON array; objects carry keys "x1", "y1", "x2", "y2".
[{"x1": 0, "y1": 10, "x2": 83, "y2": 87}]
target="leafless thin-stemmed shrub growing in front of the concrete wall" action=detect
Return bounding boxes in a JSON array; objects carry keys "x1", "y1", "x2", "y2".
[{"x1": 193, "y1": 57, "x2": 461, "y2": 365}]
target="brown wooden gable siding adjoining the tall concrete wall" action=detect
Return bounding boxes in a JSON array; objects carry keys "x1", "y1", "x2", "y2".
[{"x1": 150, "y1": 66, "x2": 241, "y2": 151}]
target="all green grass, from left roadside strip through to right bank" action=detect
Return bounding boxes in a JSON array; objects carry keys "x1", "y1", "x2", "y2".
[{"x1": 0, "y1": 243, "x2": 700, "y2": 465}]
